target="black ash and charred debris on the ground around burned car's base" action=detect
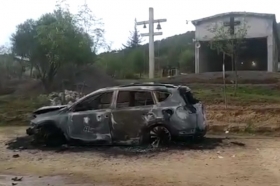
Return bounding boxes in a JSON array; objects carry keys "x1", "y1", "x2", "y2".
[{"x1": 6, "y1": 136, "x2": 245, "y2": 156}]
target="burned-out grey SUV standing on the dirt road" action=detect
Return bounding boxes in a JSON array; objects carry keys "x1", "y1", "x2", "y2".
[{"x1": 26, "y1": 83, "x2": 207, "y2": 145}]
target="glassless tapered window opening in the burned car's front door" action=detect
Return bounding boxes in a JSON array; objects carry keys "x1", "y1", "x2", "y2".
[{"x1": 74, "y1": 92, "x2": 113, "y2": 112}]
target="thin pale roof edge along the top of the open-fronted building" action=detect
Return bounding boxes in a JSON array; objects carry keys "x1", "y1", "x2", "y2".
[{"x1": 192, "y1": 12, "x2": 280, "y2": 52}]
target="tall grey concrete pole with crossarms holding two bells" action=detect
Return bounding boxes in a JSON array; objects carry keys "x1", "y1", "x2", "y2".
[{"x1": 136, "y1": 8, "x2": 167, "y2": 79}]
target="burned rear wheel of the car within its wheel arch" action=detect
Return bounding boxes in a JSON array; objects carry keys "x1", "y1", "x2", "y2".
[{"x1": 142, "y1": 125, "x2": 172, "y2": 148}]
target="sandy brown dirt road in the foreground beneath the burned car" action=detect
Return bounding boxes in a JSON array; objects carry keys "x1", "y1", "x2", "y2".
[{"x1": 0, "y1": 128, "x2": 280, "y2": 186}]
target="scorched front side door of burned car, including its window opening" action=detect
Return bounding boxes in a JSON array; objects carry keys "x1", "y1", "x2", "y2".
[{"x1": 68, "y1": 91, "x2": 113, "y2": 143}]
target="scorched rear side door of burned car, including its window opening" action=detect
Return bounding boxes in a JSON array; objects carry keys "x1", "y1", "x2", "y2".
[{"x1": 112, "y1": 91, "x2": 155, "y2": 144}]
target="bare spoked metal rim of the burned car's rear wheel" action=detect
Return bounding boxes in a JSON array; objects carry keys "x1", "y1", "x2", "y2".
[{"x1": 150, "y1": 126, "x2": 171, "y2": 147}]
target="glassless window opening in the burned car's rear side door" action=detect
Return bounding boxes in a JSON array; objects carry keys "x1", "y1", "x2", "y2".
[{"x1": 117, "y1": 91, "x2": 154, "y2": 108}]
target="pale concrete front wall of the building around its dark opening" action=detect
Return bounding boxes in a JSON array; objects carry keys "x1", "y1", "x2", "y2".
[{"x1": 195, "y1": 16, "x2": 278, "y2": 73}]
